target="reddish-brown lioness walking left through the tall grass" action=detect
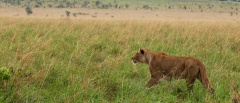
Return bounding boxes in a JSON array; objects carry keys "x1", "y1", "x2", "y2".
[{"x1": 131, "y1": 48, "x2": 214, "y2": 93}]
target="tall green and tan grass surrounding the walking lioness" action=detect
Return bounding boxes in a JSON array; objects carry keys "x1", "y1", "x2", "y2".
[{"x1": 0, "y1": 17, "x2": 240, "y2": 103}]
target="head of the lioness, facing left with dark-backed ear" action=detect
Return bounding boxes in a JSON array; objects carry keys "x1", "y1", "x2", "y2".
[{"x1": 131, "y1": 48, "x2": 146, "y2": 64}]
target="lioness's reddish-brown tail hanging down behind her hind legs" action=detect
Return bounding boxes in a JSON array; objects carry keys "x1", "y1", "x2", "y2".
[{"x1": 198, "y1": 62, "x2": 214, "y2": 93}]
